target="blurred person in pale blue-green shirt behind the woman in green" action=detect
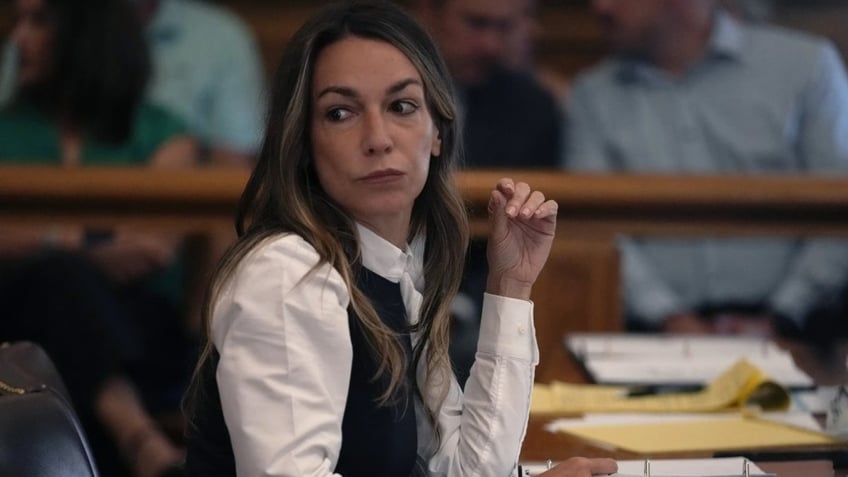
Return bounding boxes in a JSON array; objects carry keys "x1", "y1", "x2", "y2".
[{"x1": 0, "y1": 0, "x2": 265, "y2": 167}]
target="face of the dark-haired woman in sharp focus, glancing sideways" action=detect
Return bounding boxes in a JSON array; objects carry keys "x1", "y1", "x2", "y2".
[{"x1": 311, "y1": 36, "x2": 441, "y2": 238}]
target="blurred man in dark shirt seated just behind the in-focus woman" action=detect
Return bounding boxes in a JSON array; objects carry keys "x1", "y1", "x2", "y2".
[{"x1": 415, "y1": 0, "x2": 562, "y2": 385}]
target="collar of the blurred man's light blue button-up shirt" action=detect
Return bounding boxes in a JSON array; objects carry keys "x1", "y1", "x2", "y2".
[{"x1": 617, "y1": 9, "x2": 744, "y2": 82}]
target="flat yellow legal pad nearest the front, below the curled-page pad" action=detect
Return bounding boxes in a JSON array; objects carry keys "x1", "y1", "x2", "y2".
[{"x1": 564, "y1": 416, "x2": 838, "y2": 454}]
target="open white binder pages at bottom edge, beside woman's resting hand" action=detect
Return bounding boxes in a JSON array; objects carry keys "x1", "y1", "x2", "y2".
[{"x1": 522, "y1": 457, "x2": 774, "y2": 477}]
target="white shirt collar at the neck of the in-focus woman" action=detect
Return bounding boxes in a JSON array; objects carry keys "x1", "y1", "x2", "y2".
[{"x1": 356, "y1": 223, "x2": 424, "y2": 291}]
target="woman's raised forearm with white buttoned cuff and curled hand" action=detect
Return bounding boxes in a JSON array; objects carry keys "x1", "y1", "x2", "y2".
[{"x1": 430, "y1": 179, "x2": 557, "y2": 476}]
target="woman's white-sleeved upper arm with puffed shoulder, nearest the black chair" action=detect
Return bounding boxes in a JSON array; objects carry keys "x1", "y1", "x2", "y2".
[{"x1": 211, "y1": 235, "x2": 352, "y2": 477}]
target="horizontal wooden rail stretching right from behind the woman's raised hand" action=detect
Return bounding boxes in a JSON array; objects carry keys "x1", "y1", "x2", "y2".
[{"x1": 458, "y1": 170, "x2": 848, "y2": 240}]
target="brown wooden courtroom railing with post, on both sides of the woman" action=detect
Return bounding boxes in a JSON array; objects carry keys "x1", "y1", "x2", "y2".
[{"x1": 0, "y1": 166, "x2": 848, "y2": 382}]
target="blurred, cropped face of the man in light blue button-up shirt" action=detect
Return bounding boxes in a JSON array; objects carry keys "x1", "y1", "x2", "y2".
[{"x1": 592, "y1": 0, "x2": 668, "y2": 55}]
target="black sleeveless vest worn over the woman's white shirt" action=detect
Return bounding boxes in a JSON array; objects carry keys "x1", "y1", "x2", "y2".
[{"x1": 186, "y1": 268, "x2": 421, "y2": 477}]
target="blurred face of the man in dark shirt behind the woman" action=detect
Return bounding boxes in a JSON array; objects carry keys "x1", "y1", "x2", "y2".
[{"x1": 433, "y1": 0, "x2": 524, "y2": 84}]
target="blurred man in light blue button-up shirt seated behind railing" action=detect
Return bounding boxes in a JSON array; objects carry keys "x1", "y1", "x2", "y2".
[{"x1": 563, "y1": 0, "x2": 848, "y2": 341}]
